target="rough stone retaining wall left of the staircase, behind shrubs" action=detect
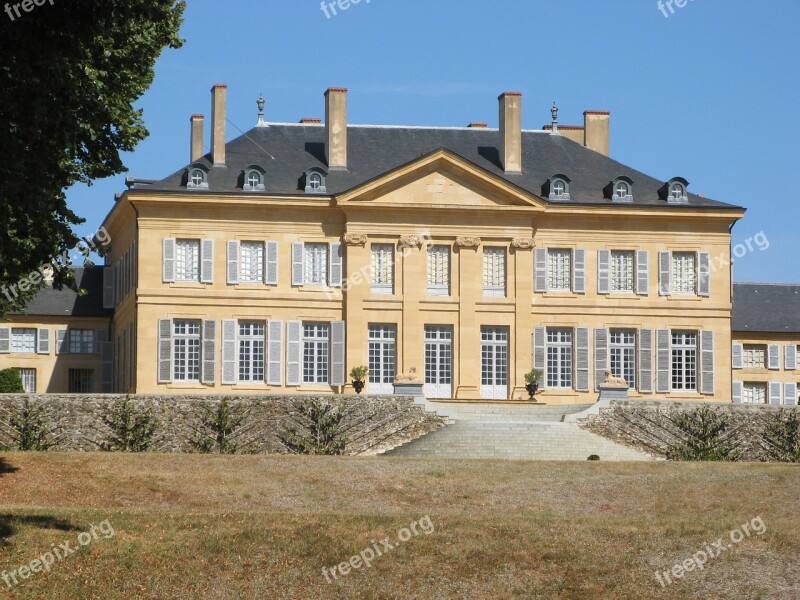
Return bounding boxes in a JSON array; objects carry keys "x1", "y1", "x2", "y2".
[{"x1": 0, "y1": 394, "x2": 446, "y2": 455}]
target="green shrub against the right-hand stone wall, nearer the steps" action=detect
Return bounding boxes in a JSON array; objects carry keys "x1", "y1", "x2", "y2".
[{"x1": 667, "y1": 406, "x2": 741, "y2": 461}]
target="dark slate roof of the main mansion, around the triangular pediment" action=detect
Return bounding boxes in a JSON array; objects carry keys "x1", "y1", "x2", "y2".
[{"x1": 132, "y1": 123, "x2": 741, "y2": 210}]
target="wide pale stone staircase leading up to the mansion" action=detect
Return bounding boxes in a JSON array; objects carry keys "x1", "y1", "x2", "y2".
[{"x1": 384, "y1": 399, "x2": 652, "y2": 461}]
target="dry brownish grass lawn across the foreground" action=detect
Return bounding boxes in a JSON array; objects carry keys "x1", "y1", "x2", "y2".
[{"x1": 0, "y1": 453, "x2": 800, "y2": 600}]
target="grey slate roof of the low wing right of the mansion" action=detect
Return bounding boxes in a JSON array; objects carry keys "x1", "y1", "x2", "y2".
[{"x1": 732, "y1": 283, "x2": 800, "y2": 333}]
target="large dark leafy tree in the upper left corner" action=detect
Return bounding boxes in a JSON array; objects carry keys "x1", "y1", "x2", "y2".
[{"x1": 0, "y1": 0, "x2": 185, "y2": 315}]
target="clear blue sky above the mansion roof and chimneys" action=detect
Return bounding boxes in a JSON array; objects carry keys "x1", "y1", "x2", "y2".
[{"x1": 68, "y1": 0, "x2": 800, "y2": 282}]
